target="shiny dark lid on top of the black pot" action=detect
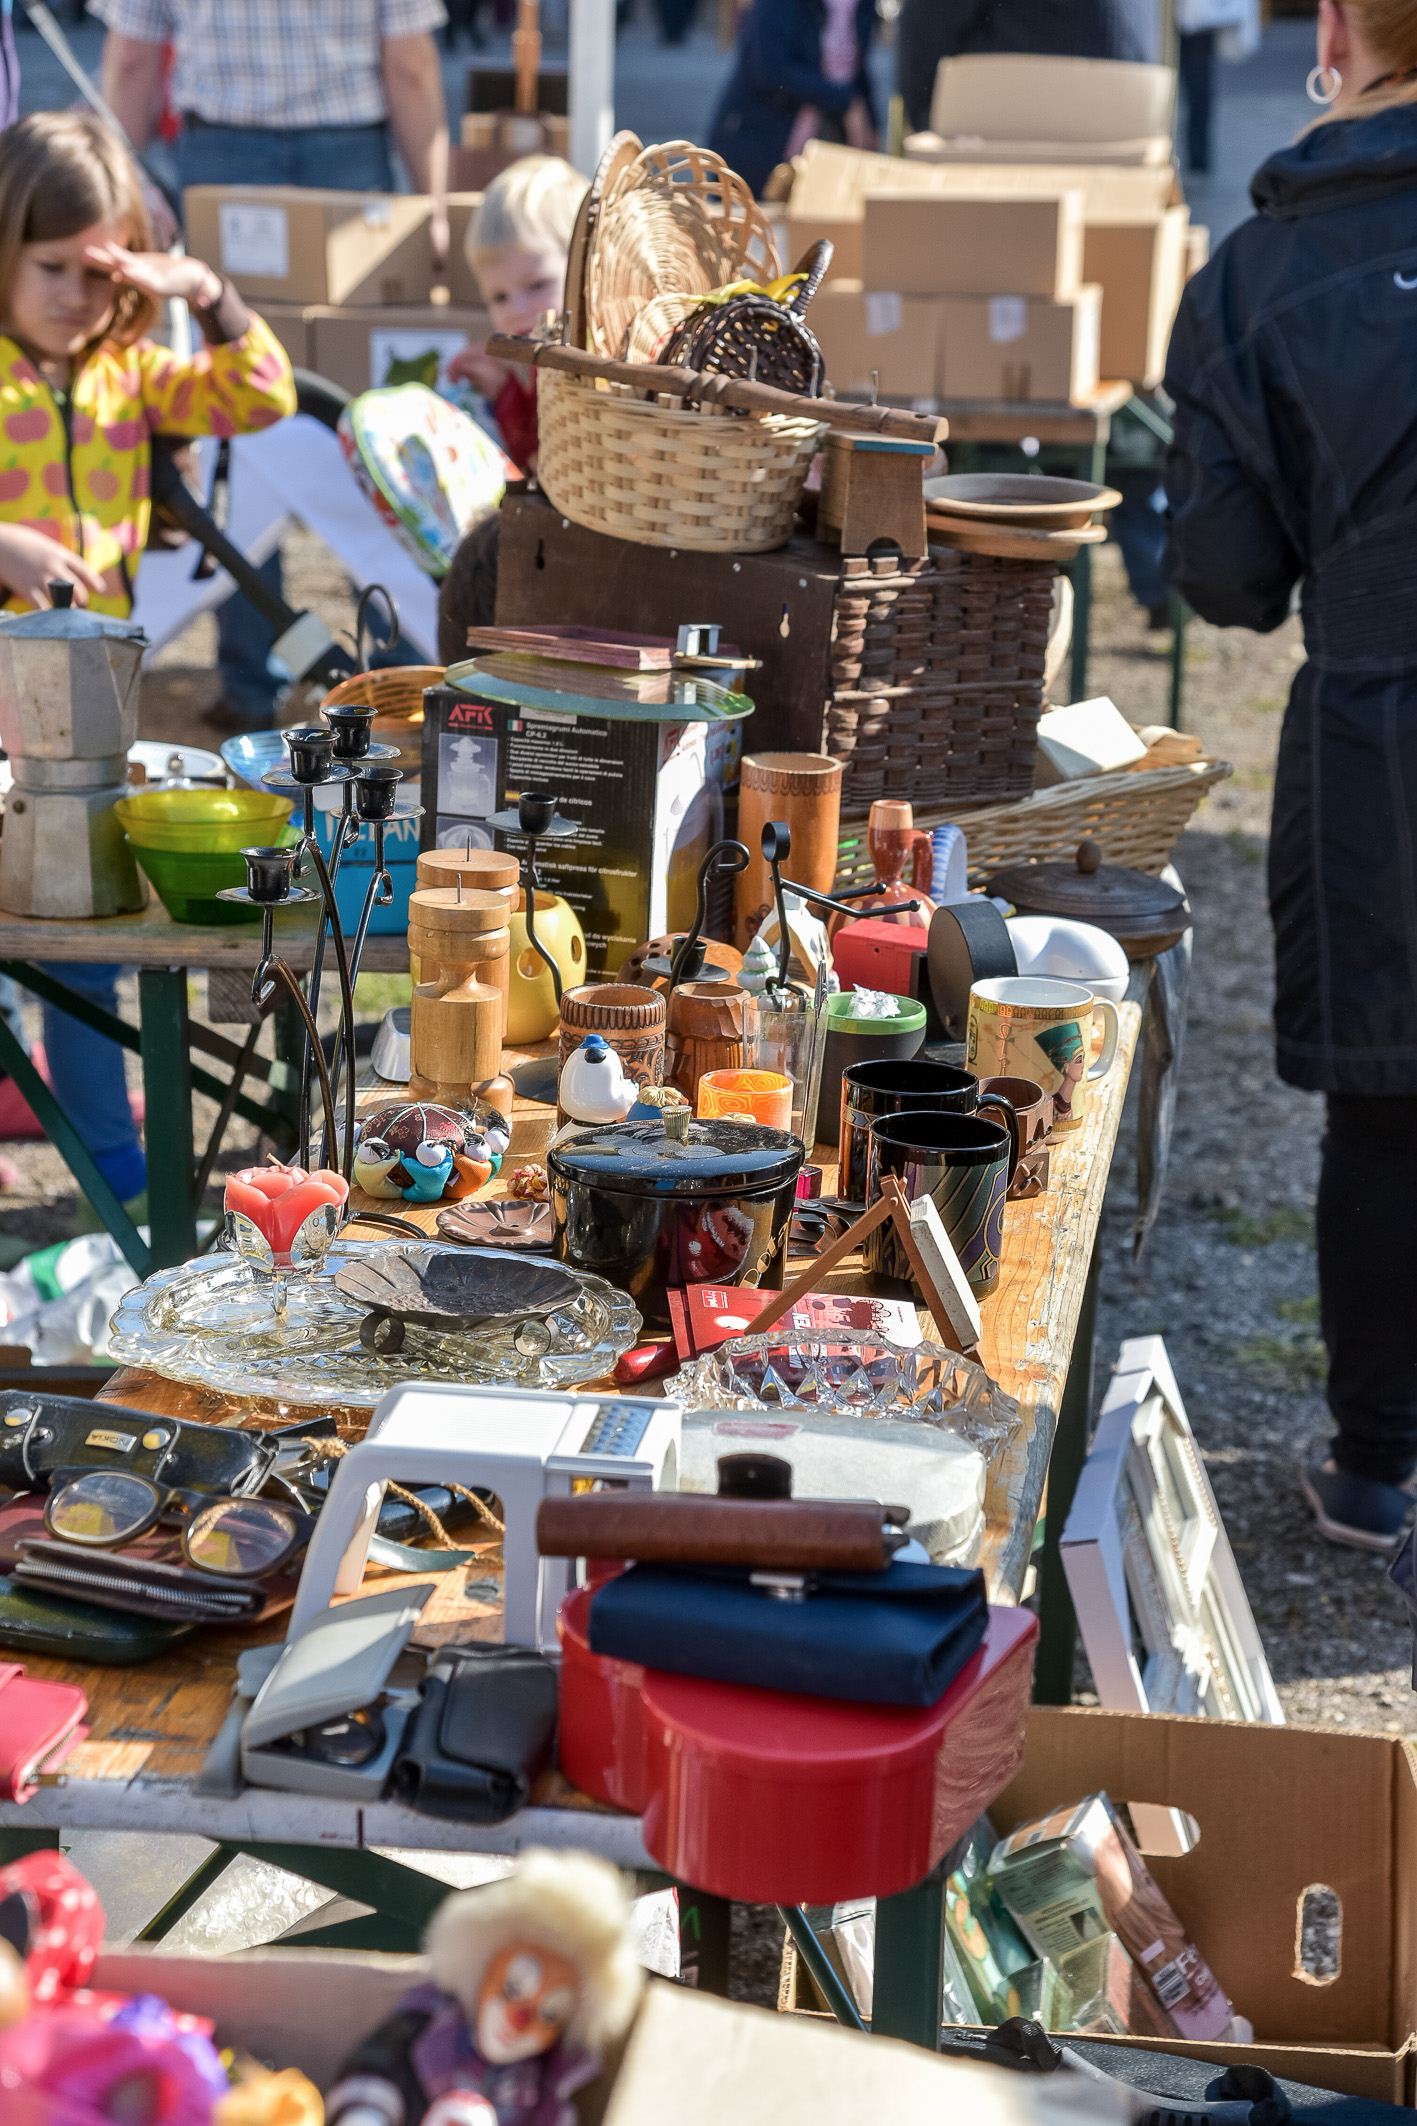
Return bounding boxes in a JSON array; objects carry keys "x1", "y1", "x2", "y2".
[{"x1": 546, "y1": 1118, "x2": 807, "y2": 1197}]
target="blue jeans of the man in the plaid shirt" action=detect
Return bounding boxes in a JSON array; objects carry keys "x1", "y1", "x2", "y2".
[{"x1": 176, "y1": 119, "x2": 393, "y2": 729}]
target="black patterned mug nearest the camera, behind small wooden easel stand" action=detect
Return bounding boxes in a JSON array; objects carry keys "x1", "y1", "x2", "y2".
[{"x1": 865, "y1": 1095, "x2": 1022, "y2": 1299}]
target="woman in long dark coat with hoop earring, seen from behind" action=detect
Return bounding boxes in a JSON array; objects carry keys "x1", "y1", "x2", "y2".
[{"x1": 1166, "y1": 0, "x2": 1417, "y2": 1550}]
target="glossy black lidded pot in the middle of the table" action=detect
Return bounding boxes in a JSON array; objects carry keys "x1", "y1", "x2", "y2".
[{"x1": 546, "y1": 1110, "x2": 807, "y2": 1327}]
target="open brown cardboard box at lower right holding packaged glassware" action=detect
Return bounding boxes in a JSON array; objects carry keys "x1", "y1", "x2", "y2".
[{"x1": 782, "y1": 1705, "x2": 1417, "y2": 2105}]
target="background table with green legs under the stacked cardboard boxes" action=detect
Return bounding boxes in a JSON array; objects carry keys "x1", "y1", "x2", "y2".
[{"x1": 934, "y1": 383, "x2": 1190, "y2": 729}]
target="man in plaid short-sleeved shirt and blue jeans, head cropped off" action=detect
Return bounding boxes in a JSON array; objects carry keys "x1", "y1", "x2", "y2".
[{"x1": 91, "y1": 0, "x2": 448, "y2": 729}]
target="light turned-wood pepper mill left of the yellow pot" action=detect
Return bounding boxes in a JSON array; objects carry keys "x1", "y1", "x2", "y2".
[{"x1": 408, "y1": 887, "x2": 512, "y2": 1116}]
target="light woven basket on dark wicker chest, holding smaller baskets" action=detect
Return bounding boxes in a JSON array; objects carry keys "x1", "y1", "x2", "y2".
[{"x1": 537, "y1": 368, "x2": 824, "y2": 553}]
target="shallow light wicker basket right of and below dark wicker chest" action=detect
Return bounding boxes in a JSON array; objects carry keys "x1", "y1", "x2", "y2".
[{"x1": 837, "y1": 761, "x2": 1232, "y2": 887}]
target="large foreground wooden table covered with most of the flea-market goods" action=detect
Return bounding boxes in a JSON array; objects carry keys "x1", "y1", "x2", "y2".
[{"x1": 0, "y1": 999, "x2": 1141, "y2": 2047}]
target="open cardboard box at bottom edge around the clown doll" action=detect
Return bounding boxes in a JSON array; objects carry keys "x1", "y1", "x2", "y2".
[{"x1": 83, "y1": 1947, "x2": 1126, "y2": 2126}]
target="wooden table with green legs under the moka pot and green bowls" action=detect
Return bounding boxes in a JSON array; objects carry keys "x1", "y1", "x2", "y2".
[{"x1": 0, "y1": 899, "x2": 408, "y2": 1276}]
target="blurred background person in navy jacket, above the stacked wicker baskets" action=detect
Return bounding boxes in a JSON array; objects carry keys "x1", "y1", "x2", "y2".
[{"x1": 710, "y1": 0, "x2": 877, "y2": 191}]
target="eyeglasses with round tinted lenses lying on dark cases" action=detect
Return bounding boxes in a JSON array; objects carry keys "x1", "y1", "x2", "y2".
[{"x1": 45, "y1": 1469, "x2": 312, "y2": 1580}]
